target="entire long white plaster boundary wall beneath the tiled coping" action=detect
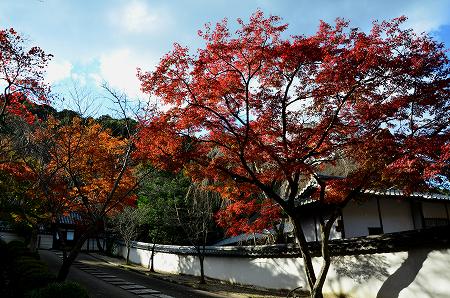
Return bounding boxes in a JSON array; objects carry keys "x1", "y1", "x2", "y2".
[{"x1": 113, "y1": 246, "x2": 450, "y2": 298}]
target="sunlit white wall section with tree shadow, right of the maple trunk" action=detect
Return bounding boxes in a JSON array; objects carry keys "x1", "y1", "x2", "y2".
[{"x1": 325, "y1": 249, "x2": 450, "y2": 298}]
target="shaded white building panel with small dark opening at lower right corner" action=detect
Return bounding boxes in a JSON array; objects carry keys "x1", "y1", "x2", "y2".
[{"x1": 342, "y1": 198, "x2": 380, "y2": 238}]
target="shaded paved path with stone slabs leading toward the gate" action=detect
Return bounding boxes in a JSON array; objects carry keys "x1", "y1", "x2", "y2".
[{"x1": 39, "y1": 250, "x2": 222, "y2": 298}]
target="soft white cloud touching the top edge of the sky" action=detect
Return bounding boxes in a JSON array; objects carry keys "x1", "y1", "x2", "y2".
[{"x1": 110, "y1": 0, "x2": 171, "y2": 33}]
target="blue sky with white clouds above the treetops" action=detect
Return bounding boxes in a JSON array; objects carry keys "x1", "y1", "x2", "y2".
[{"x1": 0, "y1": 0, "x2": 450, "y2": 114}]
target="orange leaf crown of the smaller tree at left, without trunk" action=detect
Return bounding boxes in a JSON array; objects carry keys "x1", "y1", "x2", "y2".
[{"x1": 26, "y1": 118, "x2": 136, "y2": 220}]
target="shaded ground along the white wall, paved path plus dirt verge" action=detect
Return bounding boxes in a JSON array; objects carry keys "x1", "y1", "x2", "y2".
[{"x1": 40, "y1": 250, "x2": 308, "y2": 298}]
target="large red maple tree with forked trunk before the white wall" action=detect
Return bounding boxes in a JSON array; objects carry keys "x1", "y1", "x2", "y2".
[{"x1": 138, "y1": 11, "x2": 450, "y2": 297}]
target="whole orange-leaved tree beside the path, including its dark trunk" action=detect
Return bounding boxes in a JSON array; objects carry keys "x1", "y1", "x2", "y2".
[{"x1": 8, "y1": 117, "x2": 138, "y2": 280}]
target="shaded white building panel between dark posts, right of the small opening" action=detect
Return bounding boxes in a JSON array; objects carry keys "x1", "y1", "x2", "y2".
[{"x1": 380, "y1": 199, "x2": 414, "y2": 233}]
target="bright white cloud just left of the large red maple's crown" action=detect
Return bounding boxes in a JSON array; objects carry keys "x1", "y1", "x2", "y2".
[{"x1": 96, "y1": 48, "x2": 156, "y2": 97}]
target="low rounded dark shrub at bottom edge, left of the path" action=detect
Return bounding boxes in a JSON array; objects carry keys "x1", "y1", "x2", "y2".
[{"x1": 28, "y1": 281, "x2": 89, "y2": 298}]
